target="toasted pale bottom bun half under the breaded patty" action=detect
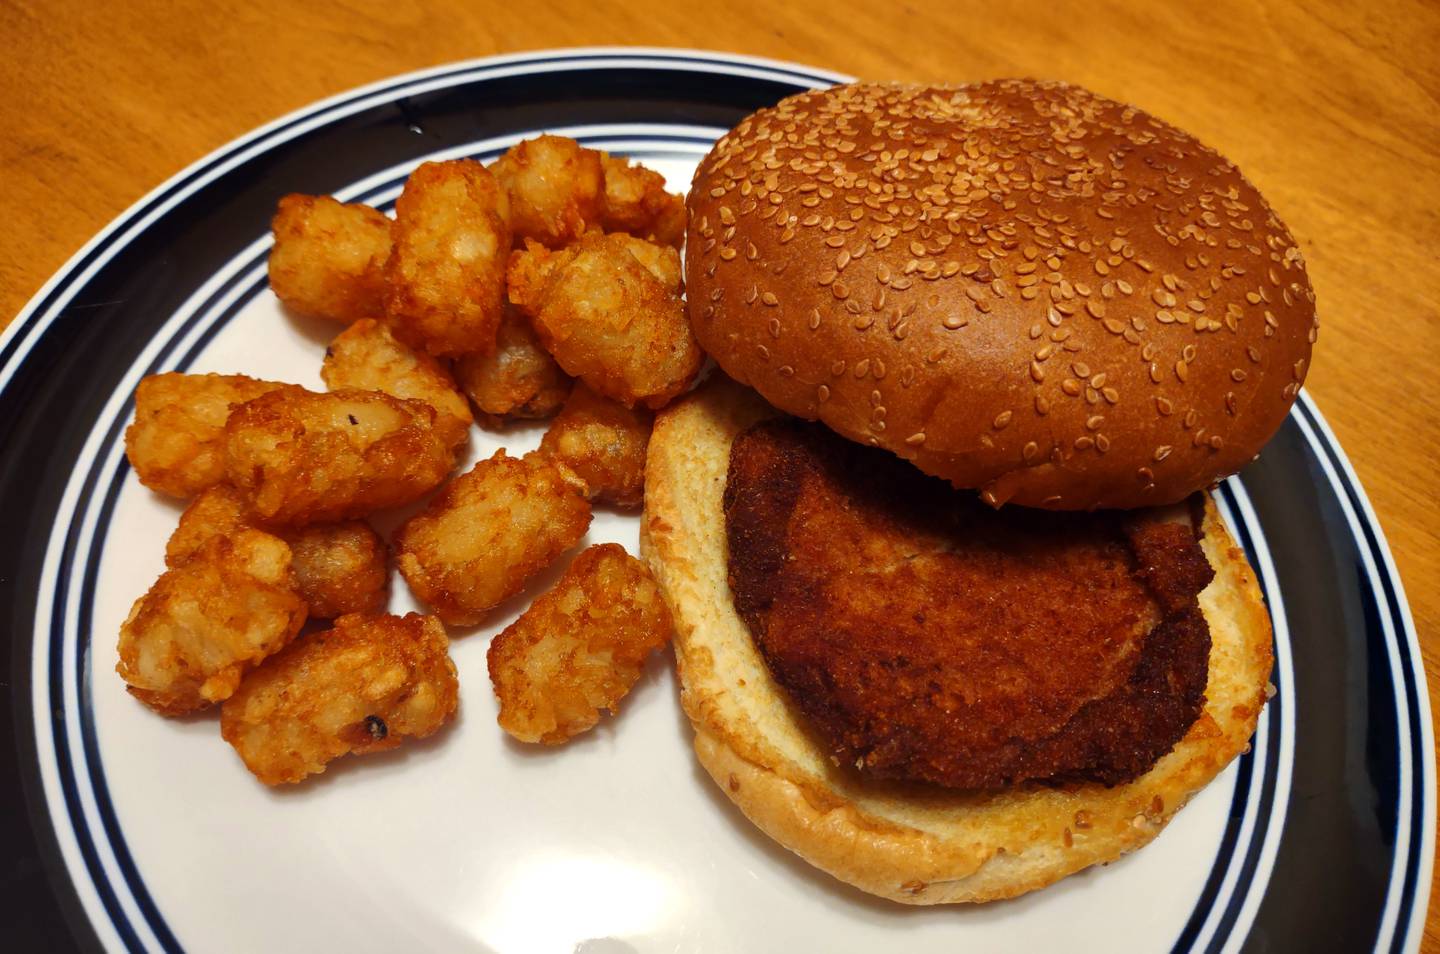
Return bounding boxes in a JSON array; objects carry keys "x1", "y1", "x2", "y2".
[{"x1": 641, "y1": 375, "x2": 1272, "y2": 905}]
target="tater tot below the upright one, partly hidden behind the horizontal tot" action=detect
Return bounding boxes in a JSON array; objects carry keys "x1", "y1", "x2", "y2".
[{"x1": 320, "y1": 318, "x2": 475, "y2": 444}]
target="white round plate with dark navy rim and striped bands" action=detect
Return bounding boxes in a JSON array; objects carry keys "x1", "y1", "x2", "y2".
[{"x1": 0, "y1": 49, "x2": 1436, "y2": 954}]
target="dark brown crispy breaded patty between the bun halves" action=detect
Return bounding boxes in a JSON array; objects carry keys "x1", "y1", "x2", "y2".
[{"x1": 724, "y1": 421, "x2": 1212, "y2": 788}]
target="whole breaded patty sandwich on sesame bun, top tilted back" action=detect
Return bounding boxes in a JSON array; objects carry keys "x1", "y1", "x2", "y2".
[{"x1": 642, "y1": 81, "x2": 1316, "y2": 904}]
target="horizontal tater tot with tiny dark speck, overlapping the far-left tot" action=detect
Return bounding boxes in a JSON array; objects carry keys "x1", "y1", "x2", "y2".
[{"x1": 225, "y1": 386, "x2": 455, "y2": 526}]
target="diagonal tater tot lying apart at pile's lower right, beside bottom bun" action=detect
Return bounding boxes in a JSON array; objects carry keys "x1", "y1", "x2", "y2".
[{"x1": 487, "y1": 543, "x2": 672, "y2": 745}]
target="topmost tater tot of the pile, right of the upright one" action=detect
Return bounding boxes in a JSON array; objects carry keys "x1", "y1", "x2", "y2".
[{"x1": 490, "y1": 135, "x2": 605, "y2": 248}]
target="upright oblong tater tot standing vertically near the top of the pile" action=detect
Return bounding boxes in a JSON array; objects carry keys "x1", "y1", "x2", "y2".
[{"x1": 384, "y1": 159, "x2": 511, "y2": 355}]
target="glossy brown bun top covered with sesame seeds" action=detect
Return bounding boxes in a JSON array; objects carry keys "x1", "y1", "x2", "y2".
[{"x1": 685, "y1": 79, "x2": 1316, "y2": 510}]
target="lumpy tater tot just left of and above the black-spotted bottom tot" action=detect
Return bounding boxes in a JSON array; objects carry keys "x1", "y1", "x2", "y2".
[{"x1": 115, "y1": 530, "x2": 305, "y2": 715}]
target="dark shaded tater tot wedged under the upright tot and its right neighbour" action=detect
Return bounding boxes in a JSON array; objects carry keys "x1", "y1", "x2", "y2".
[{"x1": 455, "y1": 306, "x2": 573, "y2": 419}]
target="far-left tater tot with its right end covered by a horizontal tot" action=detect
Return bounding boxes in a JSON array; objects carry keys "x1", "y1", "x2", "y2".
[{"x1": 125, "y1": 372, "x2": 284, "y2": 497}]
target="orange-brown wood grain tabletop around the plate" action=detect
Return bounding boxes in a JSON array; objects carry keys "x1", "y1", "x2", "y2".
[{"x1": 0, "y1": 0, "x2": 1440, "y2": 950}]
